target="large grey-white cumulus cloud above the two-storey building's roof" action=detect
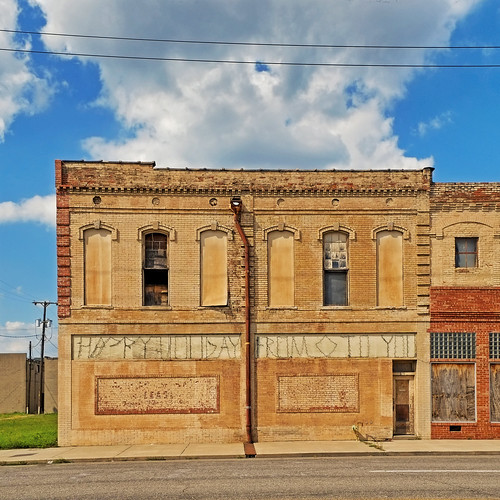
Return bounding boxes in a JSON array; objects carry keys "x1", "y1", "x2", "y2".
[{"x1": 30, "y1": 0, "x2": 480, "y2": 169}]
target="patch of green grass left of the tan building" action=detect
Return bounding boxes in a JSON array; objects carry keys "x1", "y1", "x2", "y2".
[{"x1": 0, "y1": 413, "x2": 57, "y2": 450}]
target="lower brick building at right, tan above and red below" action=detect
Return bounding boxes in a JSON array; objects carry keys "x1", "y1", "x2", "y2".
[{"x1": 430, "y1": 183, "x2": 500, "y2": 439}]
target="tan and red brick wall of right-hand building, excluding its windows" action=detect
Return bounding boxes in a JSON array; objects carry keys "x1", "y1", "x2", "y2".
[{"x1": 430, "y1": 183, "x2": 500, "y2": 439}]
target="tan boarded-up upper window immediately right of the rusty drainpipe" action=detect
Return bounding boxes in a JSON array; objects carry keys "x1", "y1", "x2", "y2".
[{"x1": 267, "y1": 231, "x2": 295, "y2": 307}]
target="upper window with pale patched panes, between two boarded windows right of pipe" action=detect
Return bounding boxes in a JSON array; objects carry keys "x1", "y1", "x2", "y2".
[{"x1": 323, "y1": 231, "x2": 348, "y2": 306}]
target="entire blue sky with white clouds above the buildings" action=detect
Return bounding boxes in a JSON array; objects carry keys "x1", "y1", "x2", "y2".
[{"x1": 0, "y1": 0, "x2": 500, "y2": 356}]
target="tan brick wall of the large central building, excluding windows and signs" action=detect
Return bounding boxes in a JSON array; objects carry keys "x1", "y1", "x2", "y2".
[{"x1": 56, "y1": 162, "x2": 431, "y2": 445}]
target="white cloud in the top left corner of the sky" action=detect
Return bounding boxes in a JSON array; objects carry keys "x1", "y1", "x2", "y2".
[{"x1": 0, "y1": 0, "x2": 53, "y2": 142}]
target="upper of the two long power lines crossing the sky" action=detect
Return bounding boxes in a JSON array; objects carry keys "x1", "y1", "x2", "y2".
[{"x1": 0, "y1": 29, "x2": 500, "y2": 50}]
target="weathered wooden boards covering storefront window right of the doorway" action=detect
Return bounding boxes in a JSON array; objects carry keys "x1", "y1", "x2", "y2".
[{"x1": 432, "y1": 363, "x2": 476, "y2": 422}]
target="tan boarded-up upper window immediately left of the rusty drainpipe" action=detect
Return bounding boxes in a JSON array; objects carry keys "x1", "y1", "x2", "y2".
[{"x1": 200, "y1": 231, "x2": 227, "y2": 306}]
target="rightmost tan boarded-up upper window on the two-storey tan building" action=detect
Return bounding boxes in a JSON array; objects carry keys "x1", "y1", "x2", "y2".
[{"x1": 377, "y1": 231, "x2": 403, "y2": 307}]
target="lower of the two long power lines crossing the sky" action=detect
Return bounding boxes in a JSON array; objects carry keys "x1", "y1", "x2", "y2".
[{"x1": 0, "y1": 47, "x2": 500, "y2": 69}]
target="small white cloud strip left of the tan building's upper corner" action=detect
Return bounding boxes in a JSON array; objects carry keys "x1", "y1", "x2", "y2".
[{"x1": 0, "y1": 194, "x2": 56, "y2": 226}]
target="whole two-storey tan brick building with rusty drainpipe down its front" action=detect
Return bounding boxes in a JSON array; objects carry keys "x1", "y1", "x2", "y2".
[{"x1": 56, "y1": 161, "x2": 500, "y2": 445}]
